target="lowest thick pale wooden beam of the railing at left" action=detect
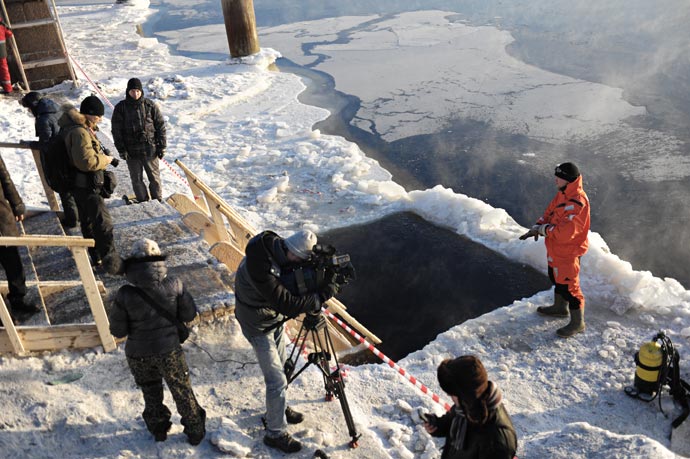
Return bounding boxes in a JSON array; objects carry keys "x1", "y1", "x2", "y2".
[{"x1": 0, "y1": 323, "x2": 101, "y2": 352}]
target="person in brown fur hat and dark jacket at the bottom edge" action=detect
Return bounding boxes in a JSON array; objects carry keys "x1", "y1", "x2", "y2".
[{"x1": 422, "y1": 355, "x2": 517, "y2": 459}]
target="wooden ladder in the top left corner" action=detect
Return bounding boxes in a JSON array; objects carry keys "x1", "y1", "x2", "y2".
[{"x1": 0, "y1": 0, "x2": 77, "y2": 91}]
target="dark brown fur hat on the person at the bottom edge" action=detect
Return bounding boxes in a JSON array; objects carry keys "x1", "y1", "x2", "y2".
[{"x1": 437, "y1": 355, "x2": 489, "y2": 403}]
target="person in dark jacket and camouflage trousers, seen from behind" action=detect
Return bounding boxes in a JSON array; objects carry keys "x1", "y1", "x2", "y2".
[{"x1": 109, "y1": 239, "x2": 206, "y2": 445}]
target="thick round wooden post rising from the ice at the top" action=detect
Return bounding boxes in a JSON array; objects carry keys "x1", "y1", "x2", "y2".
[{"x1": 221, "y1": 0, "x2": 259, "y2": 57}]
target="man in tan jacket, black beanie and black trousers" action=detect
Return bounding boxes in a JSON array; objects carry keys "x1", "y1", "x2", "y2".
[{"x1": 58, "y1": 95, "x2": 122, "y2": 274}]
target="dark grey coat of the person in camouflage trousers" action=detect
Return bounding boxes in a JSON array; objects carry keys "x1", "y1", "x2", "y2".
[{"x1": 108, "y1": 256, "x2": 197, "y2": 357}]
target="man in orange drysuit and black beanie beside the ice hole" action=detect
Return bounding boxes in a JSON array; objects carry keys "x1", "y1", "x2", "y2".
[{"x1": 520, "y1": 163, "x2": 589, "y2": 338}]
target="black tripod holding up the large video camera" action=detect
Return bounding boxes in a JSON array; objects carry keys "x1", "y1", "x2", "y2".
[{"x1": 285, "y1": 313, "x2": 361, "y2": 448}]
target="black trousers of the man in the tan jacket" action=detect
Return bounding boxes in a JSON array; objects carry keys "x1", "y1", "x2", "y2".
[{"x1": 72, "y1": 188, "x2": 115, "y2": 262}]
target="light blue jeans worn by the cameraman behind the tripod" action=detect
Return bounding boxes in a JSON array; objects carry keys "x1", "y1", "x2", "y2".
[{"x1": 245, "y1": 325, "x2": 287, "y2": 437}]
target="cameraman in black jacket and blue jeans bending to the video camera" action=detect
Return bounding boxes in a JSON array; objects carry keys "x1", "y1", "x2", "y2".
[{"x1": 235, "y1": 230, "x2": 338, "y2": 453}]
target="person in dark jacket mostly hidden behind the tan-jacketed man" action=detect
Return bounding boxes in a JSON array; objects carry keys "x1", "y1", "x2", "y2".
[{"x1": 21, "y1": 91, "x2": 79, "y2": 229}]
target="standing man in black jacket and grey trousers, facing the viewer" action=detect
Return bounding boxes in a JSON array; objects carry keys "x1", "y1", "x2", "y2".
[{"x1": 112, "y1": 78, "x2": 167, "y2": 202}]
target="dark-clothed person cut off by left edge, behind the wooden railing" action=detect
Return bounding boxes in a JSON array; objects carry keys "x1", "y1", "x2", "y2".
[{"x1": 0, "y1": 157, "x2": 38, "y2": 319}]
